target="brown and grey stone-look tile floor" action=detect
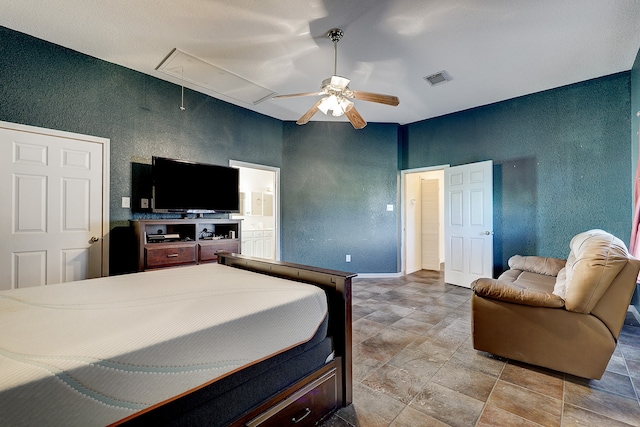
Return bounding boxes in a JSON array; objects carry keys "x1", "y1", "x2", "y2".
[{"x1": 323, "y1": 271, "x2": 640, "y2": 427}]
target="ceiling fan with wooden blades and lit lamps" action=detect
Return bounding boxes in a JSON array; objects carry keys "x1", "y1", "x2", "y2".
[{"x1": 273, "y1": 28, "x2": 400, "y2": 129}]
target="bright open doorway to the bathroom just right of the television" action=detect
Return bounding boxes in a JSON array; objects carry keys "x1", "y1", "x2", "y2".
[{"x1": 229, "y1": 160, "x2": 280, "y2": 260}]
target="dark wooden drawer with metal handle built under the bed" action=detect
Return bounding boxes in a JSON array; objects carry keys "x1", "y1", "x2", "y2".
[{"x1": 245, "y1": 368, "x2": 337, "y2": 427}]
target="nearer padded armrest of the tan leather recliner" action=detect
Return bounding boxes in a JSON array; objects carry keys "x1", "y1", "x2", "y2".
[{"x1": 471, "y1": 278, "x2": 564, "y2": 308}]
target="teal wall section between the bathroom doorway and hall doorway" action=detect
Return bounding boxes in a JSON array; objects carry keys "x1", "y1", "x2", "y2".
[{"x1": 280, "y1": 122, "x2": 399, "y2": 273}]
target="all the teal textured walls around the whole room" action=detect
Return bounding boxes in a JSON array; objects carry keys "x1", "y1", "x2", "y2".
[{"x1": 0, "y1": 27, "x2": 640, "y2": 273}]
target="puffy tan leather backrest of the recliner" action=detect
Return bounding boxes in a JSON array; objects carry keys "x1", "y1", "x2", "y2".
[{"x1": 553, "y1": 229, "x2": 629, "y2": 313}]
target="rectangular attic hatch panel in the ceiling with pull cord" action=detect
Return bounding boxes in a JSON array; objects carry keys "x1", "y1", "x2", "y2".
[{"x1": 156, "y1": 49, "x2": 275, "y2": 105}]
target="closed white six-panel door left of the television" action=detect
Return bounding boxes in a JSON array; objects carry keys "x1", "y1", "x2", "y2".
[{"x1": 0, "y1": 123, "x2": 108, "y2": 289}]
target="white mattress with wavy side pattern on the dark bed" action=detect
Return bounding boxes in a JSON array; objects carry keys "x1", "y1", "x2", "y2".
[{"x1": 0, "y1": 264, "x2": 327, "y2": 426}]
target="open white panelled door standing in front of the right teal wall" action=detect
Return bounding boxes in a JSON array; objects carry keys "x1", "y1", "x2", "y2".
[{"x1": 444, "y1": 160, "x2": 493, "y2": 288}]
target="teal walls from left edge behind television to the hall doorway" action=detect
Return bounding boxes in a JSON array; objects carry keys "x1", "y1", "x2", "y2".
[{"x1": 0, "y1": 27, "x2": 398, "y2": 273}]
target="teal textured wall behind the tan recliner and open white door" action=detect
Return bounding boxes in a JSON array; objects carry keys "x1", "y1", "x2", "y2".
[{"x1": 402, "y1": 72, "x2": 632, "y2": 270}]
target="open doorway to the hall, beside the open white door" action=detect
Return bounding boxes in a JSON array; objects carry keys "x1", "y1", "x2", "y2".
[{"x1": 402, "y1": 165, "x2": 448, "y2": 274}]
